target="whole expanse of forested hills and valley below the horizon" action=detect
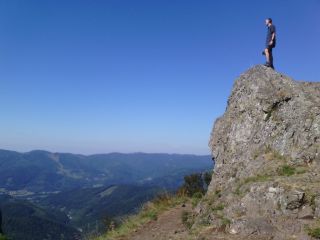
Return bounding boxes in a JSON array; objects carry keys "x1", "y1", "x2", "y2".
[{"x1": 0, "y1": 150, "x2": 213, "y2": 240}]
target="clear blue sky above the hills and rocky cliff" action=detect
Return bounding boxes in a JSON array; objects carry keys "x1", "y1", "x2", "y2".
[{"x1": 0, "y1": 0, "x2": 320, "y2": 154}]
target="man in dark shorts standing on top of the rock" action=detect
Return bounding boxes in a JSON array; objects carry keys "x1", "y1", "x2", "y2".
[{"x1": 263, "y1": 18, "x2": 276, "y2": 69}]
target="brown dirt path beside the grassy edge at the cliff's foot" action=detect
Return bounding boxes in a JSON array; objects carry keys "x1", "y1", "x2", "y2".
[{"x1": 123, "y1": 204, "x2": 191, "y2": 240}]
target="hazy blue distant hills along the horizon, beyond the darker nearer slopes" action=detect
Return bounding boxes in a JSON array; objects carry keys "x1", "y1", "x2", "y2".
[{"x1": 0, "y1": 150, "x2": 212, "y2": 192}]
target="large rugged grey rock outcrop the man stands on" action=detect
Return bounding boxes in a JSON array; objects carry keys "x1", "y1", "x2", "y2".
[{"x1": 194, "y1": 65, "x2": 320, "y2": 239}]
